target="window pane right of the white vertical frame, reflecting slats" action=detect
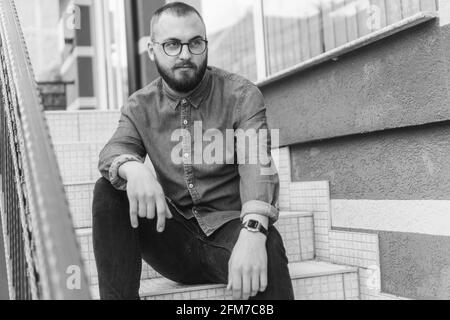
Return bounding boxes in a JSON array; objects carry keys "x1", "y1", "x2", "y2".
[{"x1": 263, "y1": 0, "x2": 437, "y2": 74}]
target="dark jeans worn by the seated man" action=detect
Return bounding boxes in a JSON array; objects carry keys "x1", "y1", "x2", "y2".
[{"x1": 93, "y1": 178, "x2": 294, "y2": 300}]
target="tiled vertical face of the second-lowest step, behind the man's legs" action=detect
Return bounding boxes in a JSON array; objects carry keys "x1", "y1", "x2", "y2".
[{"x1": 77, "y1": 212, "x2": 314, "y2": 284}]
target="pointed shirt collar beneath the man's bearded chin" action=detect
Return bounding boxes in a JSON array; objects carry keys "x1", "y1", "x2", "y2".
[{"x1": 161, "y1": 67, "x2": 211, "y2": 110}]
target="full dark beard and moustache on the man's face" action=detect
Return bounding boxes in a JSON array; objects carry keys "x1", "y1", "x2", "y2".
[{"x1": 155, "y1": 58, "x2": 208, "y2": 93}]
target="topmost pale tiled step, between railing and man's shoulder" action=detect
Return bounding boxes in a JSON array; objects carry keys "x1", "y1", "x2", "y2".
[{"x1": 45, "y1": 111, "x2": 120, "y2": 143}]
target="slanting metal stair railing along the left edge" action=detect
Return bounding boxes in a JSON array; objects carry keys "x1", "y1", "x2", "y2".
[{"x1": 0, "y1": 0, "x2": 90, "y2": 299}]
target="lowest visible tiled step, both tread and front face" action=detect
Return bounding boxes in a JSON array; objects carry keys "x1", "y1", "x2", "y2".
[{"x1": 91, "y1": 261, "x2": 359, "y2": 300}]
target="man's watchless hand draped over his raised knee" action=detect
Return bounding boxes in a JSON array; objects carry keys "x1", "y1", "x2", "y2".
[{"x1": 119, "y1": 161, "x2": 172, "y2": 232}]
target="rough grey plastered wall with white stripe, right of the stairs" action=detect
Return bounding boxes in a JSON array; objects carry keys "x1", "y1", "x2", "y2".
[{"x1": 261, "y1": 21, "x2": 450, "y2": 299}]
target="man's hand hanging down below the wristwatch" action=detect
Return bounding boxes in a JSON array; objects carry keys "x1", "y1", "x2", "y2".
[{"x1": 227, "y1": 229, "x2": 267, "y2": 300}]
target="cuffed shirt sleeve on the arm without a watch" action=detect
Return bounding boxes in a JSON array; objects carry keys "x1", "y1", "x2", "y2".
[{"x1": 98, "y1": 98, "x2": 146, "y2": 191}]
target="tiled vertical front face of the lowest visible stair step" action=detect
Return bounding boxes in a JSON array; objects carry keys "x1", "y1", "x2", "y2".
[{"x1": 121, "y1": 272, "x2": 359, "y2": 300}]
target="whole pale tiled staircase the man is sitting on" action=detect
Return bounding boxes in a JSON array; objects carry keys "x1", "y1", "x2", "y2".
[{"x1": 46, "y1": 111, "x2": 360, "y2": 300}]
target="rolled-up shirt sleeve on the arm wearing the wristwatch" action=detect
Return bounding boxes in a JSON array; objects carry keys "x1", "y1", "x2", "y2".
[{"x1": 235, "y1": 83, "x2": 279, "y2": 224}]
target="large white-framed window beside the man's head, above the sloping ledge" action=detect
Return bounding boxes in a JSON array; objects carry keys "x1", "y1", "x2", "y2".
[{"x1": 194, "y1": 0, "x2": 437, "y2": 81}]
